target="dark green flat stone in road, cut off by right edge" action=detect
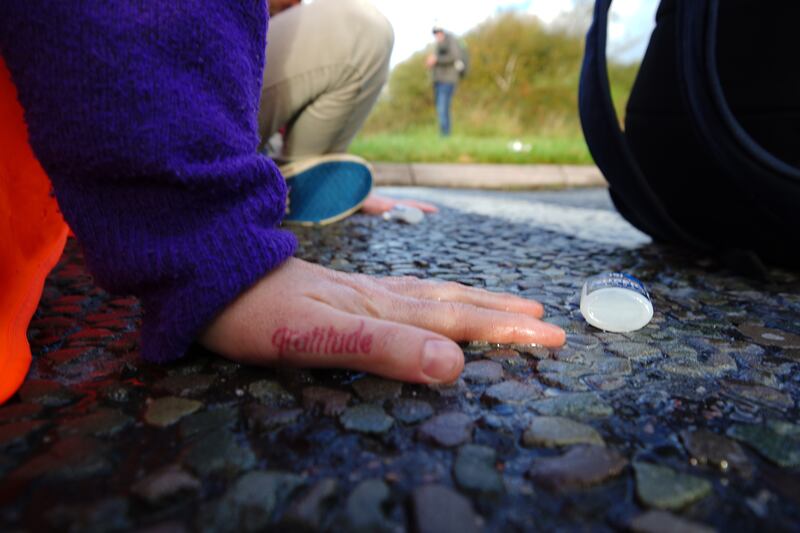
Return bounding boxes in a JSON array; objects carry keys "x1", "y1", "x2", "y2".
[{"x1": 728, "y1": 420, "x2": 800, "y2": 468}]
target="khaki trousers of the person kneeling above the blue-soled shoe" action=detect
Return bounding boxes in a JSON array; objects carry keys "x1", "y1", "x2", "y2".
[{"x1": 258, "y1": 0, "x2": 394, "y2": 160}]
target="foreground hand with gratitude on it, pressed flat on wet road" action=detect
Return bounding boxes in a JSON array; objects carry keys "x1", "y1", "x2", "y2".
[{"x1": 201, "y1": 258, "x2": 565, "y2": 383}]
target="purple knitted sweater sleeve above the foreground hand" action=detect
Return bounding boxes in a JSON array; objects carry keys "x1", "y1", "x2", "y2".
[{"x1": 0, "y1": 0, "x2": 296, "y2": 361}]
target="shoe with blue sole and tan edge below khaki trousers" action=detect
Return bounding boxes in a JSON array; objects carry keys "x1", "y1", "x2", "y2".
[{"x1": 279, "y1": 154, "x2": 372, "y2": 226}]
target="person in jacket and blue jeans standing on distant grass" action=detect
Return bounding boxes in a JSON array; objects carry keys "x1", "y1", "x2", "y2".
[{"x1": 427, "y1": 26, "x2": 461, "y2": 137}]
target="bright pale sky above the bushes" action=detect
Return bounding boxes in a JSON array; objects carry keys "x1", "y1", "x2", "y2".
[{"x1": 372, "y1": 0, "x2": 658, "y2": 65}]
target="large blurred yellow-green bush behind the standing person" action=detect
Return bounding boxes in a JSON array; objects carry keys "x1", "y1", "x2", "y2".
[{"x1": 364, "y1": 13, "x2": 637, "y2": 136}]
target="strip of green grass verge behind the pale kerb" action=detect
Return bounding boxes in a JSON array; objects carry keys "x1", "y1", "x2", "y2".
[{"x1": 350, "y1": 131, "x2": 592, "y2": 164}]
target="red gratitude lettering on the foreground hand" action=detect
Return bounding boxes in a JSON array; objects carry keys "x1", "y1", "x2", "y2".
[{"x1": 272, "y1": 320, "x2": 372, "y2": 355}]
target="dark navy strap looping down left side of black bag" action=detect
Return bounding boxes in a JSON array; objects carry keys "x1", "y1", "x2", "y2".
[{"x1": 578, "y1": 0, "x2": 710, "y2": 250}]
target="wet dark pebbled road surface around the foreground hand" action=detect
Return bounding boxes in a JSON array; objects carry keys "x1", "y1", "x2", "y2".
[{"x1": 0, "y1": 192, "x2": 800, "y2": 533}]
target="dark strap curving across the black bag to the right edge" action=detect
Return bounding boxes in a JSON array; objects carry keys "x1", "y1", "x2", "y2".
[{"x1": 677, "y1": 0, "x2": 800, "y2": 220}]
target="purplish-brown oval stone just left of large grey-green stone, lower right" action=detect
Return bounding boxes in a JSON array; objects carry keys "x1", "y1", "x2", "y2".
[{"x1": 528, "y1": 446, "x2": 628, "y2": 491}]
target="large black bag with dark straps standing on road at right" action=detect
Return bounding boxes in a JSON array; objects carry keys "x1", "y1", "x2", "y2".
[{"x1": 579, "y1": 0, "x2": 800, "y2": 266}]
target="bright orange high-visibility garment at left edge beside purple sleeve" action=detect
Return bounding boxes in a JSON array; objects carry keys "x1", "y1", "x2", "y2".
[{"x1": 0, "y1": 57, "x2": 69, "y2": 404}]
